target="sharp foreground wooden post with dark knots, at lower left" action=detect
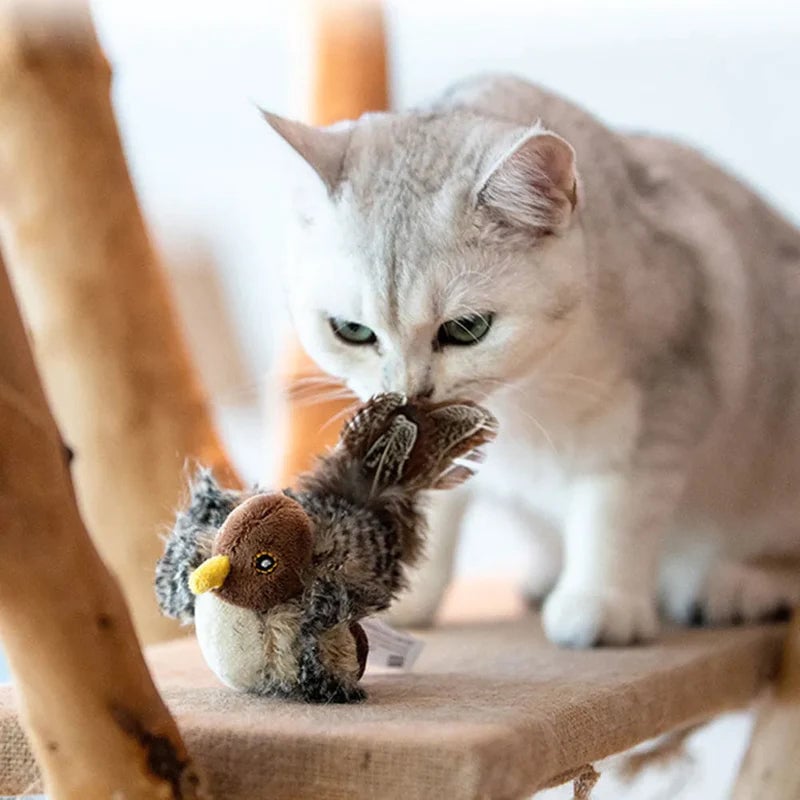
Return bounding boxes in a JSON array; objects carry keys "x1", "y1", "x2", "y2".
[{"x1": 0, "y1": 252, "x2": 206, "y2": 800}]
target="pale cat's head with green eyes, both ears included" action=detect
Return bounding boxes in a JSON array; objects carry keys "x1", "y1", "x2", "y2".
[{"x1": 271, "y1": 109, "x2": 586, "y2": 400}]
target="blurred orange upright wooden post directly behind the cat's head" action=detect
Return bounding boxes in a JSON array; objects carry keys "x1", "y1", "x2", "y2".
[{"x1": 282, "y1": 0, "x2": 389, "y2": 483}]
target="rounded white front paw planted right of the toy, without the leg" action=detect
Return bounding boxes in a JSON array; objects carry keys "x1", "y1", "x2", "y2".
[{"x1": 542, "y1": 587, "x2": 658, "y2": 648}]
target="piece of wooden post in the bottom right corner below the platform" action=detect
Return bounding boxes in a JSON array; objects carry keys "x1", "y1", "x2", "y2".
[{"x1": 733, "y1": 613, "x2": 800, "y2": 800}]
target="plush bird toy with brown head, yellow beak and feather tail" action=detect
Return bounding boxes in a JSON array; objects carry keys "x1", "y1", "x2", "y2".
[{"x1": 156, "y1": 394, "x2": 496, "y2": 702}]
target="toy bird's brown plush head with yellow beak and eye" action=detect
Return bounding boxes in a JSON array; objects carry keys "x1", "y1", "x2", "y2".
[{"x1": 189, "y1": 492, "x2": 313, "y2": 612}]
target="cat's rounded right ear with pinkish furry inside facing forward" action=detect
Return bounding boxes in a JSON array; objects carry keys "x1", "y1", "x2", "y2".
[{"x1": 478, "y1": 130, "x2": 578, "y2": 233}]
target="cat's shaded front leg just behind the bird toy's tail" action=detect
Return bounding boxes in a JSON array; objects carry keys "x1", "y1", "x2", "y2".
[{"x1": 385, "y1": 488, "x2": 469, "y2": 628}]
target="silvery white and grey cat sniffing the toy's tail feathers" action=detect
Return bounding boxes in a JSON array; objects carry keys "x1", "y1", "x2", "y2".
[{"x1": 265, "y1": 75, "x2": 800, "y2": 647}]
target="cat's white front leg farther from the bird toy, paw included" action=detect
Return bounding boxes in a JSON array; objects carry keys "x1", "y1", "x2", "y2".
[{"x1": 543, "y1": 470, "x2": 683, "y2": 647}]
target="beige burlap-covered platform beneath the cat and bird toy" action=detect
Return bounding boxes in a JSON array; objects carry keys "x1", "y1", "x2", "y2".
[{"x1": 0, "y1": 585, "x2": 785, "y2": 800}]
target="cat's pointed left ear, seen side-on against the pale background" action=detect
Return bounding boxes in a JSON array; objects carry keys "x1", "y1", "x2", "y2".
[{"x1": 261, "y1": 109, "x2": 352, "y2": 194}]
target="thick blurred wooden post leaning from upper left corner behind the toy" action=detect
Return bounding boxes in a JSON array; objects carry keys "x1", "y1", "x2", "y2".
[{"x1": 0, "y1": 0, "x2": 239, "y2": 642}]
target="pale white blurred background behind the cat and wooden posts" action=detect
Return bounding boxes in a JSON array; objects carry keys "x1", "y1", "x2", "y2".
[{"x1": 0, "y1": 0, "x2": 800, "y2": 800}]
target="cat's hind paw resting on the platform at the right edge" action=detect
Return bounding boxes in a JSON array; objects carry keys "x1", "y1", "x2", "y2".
[{"x1": 663, "y1": 562, "x2": 800, "y2": 625}]
